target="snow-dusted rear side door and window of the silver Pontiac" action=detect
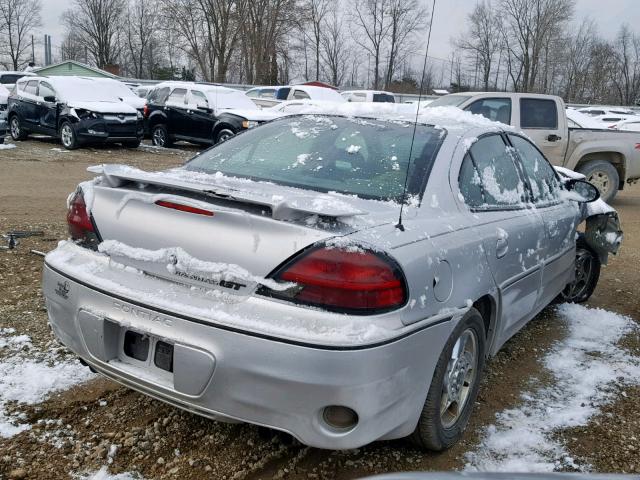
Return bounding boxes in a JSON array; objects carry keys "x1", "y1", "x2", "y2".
[{"x1": 459, "y1": 134, "x2": 544, "y2": 345}]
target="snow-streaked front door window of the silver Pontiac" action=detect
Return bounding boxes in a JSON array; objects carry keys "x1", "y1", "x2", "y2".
[{"x1": 509, "y1": 135, "x2": 560, "y2": 204}]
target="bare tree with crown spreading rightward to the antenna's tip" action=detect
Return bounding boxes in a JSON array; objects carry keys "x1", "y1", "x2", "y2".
[{"x1": 385, "y1": 0, "x2": 428, "y2": 88}]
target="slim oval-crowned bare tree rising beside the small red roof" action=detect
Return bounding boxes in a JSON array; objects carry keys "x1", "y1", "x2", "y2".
[{"x1": 320, "y1": 8, "x2": 351, "y2": 86}]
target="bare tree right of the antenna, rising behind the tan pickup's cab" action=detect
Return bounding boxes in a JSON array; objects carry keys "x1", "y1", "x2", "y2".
[{"x1": 454, "y1": 1, "x2": 502, "y2": 90}]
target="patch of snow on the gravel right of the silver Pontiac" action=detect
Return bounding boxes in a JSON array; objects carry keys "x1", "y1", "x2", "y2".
[{"x1": 466, "y1": 304, "x2": 640, "y2": 472}]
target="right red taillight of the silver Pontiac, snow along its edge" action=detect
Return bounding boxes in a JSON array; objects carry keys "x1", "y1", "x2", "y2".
[{"x1": 269, "y1": 247, "x2": 406, "y2": 314}]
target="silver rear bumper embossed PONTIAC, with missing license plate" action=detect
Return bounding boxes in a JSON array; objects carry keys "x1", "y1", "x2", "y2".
[{"x1": 43, "y1": 256, "x2": 455, "y2": 449}]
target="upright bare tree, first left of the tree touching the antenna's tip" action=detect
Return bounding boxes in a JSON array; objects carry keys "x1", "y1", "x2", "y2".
[{"x1": 352, "y1": 0, "x2": 391, "y2": 89}]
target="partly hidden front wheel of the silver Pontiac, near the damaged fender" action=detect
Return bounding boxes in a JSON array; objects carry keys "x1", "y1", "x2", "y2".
[{"x1": 556, "y1": 234, "x2": 601, "y2": 303}]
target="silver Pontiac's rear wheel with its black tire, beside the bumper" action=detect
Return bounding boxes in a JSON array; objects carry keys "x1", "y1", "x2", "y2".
[{"x1": 410, "y1": 308, "x2": 486, "y2": 452}]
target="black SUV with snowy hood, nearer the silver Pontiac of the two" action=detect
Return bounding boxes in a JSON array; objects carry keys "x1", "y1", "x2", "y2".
[{"x1": 145, "y1": 82, "x2": 279, "y2": 147}]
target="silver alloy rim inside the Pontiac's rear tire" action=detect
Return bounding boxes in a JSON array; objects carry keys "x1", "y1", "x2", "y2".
[{"x1": 440, "y1": 328, "x2": 478, "y2": 428}]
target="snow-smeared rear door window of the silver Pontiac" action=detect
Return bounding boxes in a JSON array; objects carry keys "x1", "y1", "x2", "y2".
[{"x1": 469, "y1": 135, "x2": 526, "y2": 208}]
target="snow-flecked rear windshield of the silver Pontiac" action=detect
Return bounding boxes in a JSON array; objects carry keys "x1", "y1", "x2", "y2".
[{"x1": 185, "y1": 115, "x2": 446, "y2": 201}]
